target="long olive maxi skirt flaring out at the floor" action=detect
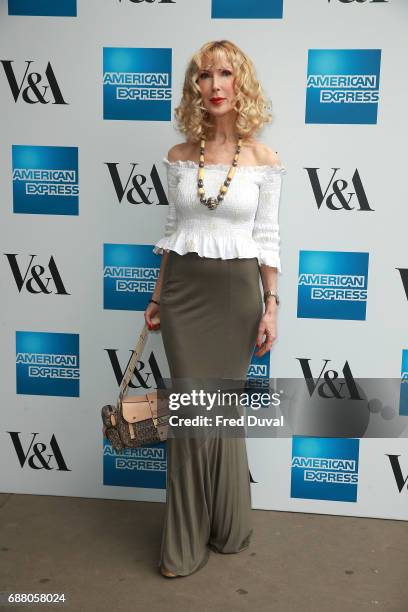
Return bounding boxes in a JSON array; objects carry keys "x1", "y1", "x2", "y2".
[{"x1": 159, "y1": 251, "x2": 263, "y2": 576}]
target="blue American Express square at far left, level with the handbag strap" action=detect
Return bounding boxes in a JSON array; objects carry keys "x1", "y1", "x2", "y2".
[{"x1": 16, "y1": 331, "x2": 80, "y2": 397}]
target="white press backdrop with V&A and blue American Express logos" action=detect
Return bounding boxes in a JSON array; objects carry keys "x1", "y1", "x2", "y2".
[{"x1": 0, "y1": 0, "x2": 408, "y2": 520}]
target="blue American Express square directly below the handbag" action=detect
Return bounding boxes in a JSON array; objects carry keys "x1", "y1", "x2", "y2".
[{"x1": 103, "y1": 438, "x2": 167, "y2": 489}]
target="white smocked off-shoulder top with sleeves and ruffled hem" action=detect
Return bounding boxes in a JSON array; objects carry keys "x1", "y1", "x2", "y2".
[{"x1": 153, "y1": 158, "x2": 286, "y2": 272}]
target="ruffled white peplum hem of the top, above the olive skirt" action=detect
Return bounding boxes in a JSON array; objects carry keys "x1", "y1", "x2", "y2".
[{"x1": 153, "y1": 232, "x2": 282, "y2": 272}]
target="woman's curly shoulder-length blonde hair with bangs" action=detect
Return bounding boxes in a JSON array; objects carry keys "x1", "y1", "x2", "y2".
[{"x1": 174, "y1": 40, "x2": 272, "y2": 142}]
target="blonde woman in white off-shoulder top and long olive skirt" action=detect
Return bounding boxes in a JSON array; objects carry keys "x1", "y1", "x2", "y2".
[{"x1": 145, "y1": 40, "x2": 285, "y2": 578}]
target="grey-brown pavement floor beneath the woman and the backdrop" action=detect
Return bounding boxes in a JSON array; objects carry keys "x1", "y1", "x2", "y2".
[{"x1": 0, "y1": 493, "x2": 408, "y2": 612}]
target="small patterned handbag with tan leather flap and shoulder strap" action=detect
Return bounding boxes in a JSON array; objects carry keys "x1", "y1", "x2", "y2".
[{"x1": 101, "y1": 323, "x2": 169, "y2": 451}]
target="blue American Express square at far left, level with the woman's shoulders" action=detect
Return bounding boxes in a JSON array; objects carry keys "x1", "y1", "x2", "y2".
[{"x1": 12, "y1": 145, "x2": 79, "y2": 215}]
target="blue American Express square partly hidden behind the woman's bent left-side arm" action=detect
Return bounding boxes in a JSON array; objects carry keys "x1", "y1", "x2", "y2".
[{"x1": 103, "y1": 244, "x2": 161, "y2": 310}]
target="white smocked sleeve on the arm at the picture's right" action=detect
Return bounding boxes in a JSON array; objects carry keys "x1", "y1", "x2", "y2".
[{"x1": 252, "y1": 166, "x2": 286, "y2": 272}]
